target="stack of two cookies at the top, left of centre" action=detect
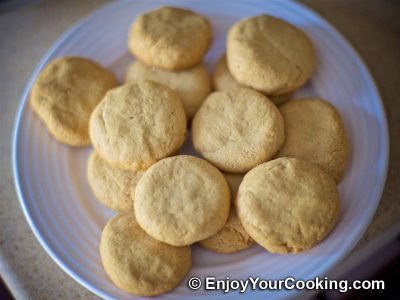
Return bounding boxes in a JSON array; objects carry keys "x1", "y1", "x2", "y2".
[{"x1": 125, "y1": 7, "x2": 212, "y2": 121}]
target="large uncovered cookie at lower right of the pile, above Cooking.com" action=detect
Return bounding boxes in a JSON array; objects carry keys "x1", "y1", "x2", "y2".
[{"x1": 236, "y1": 157, "x2": 340, "y2": 254}]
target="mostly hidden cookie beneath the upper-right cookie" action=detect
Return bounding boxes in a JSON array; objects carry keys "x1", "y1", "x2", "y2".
[{"x1": 212, "y1": 54, "x2": 292, "y2": 105}]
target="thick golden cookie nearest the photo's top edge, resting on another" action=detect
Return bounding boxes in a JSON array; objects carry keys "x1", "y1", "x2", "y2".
[{"x1": 128, "y1": 7, "x2": 212, "y2": 70}]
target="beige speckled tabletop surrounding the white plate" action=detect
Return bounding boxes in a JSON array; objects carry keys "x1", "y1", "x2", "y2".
[{"x1": 0, "y1": 0, "x2": 400, "y2": 299}]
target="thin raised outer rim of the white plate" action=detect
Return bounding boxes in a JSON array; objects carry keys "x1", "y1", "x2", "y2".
[{"x1": 11, "y1": 0, "x2": 390, "y2": 299}]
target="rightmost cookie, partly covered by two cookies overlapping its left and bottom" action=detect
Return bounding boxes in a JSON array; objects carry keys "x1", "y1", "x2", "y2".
[{"x1": 277, "y1": 98, "x2": 349, "y2": 182}]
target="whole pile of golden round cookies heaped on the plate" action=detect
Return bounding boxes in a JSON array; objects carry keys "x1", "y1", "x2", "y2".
[{"x1": 30, "y1": 7, "x2": 349, "y2": 296}]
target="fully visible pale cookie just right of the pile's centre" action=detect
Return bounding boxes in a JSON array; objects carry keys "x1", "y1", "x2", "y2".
[{"x1": 192, "y1": 88, "x2": 284, "y2": 173}]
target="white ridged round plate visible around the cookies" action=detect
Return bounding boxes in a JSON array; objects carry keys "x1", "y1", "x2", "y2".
[{"x1": 12, "y1": 0, "x2": 388, "y2": 299}]
